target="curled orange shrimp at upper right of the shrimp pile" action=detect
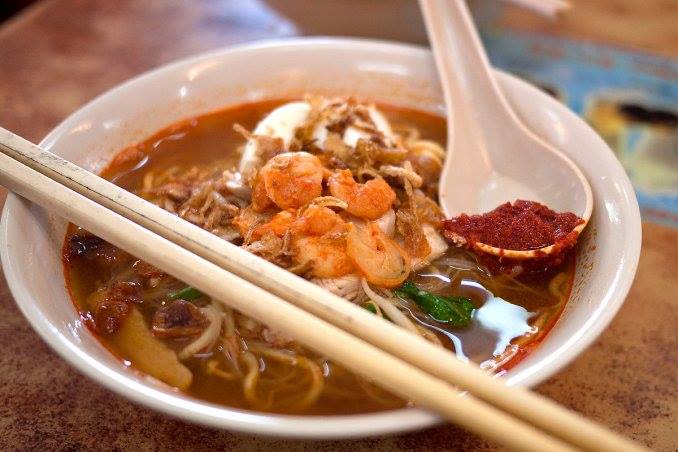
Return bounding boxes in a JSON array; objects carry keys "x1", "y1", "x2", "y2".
[{"x1": 329, "y1": 170, "x2": 396, "y2": 220}]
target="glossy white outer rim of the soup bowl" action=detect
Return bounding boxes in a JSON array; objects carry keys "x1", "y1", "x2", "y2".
[{"x1": 0, "y1": 37, "x2": 641, "y2": 439}]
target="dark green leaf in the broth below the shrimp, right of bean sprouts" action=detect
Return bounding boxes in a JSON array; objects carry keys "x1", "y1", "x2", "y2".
[{"x1": 395, "y1": 281, "x2": 475, "y2": 328}]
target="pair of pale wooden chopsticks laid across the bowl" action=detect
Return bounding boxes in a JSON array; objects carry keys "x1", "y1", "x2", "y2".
[{"x1": 0, "y1": 128, "x2": 638, "y2": 450}]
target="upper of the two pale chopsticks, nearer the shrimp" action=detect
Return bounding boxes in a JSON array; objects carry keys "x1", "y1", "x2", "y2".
[{"x1": 0, "y1": 128, "x2": 648, "y2": 450}]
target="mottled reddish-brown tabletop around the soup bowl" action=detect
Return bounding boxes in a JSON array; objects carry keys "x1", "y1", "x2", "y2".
[{"x1": 0, "y1": 0, "x2": 678, "y2": 451}]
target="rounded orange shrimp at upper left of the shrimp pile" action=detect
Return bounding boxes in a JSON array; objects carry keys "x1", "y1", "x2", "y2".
[{"x1": 254, "y1": 152, "x2": 325, "y2": 210}]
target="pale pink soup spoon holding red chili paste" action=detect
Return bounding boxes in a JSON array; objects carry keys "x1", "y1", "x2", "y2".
[{"x1": 419, "y1": 0, "x2": 593, "y2": 260}]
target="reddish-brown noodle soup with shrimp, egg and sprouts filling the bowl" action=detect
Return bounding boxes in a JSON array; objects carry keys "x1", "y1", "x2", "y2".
[{"x1": 63, "y1": 98, "x2": 574, "y2": 414}]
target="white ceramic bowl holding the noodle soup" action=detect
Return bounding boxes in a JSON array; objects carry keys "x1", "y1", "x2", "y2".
[{"x1": 1, "y1": 39, "x2": 641, "y2": 438}]
